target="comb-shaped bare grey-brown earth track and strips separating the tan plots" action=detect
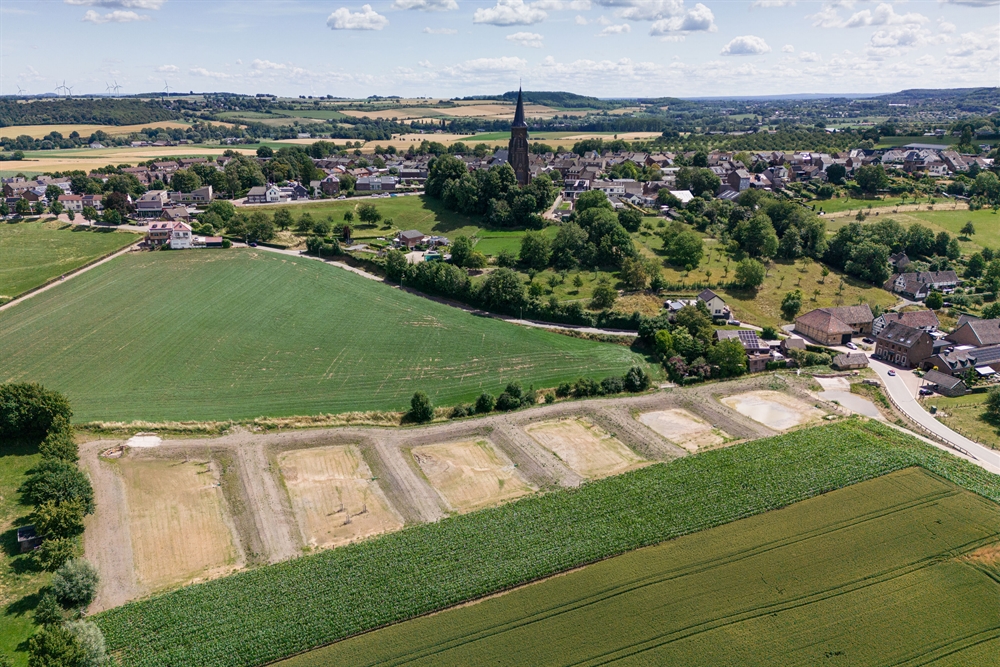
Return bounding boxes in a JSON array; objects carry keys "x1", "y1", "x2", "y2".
[{"x1": 81, "y1": 378, "x2": 828, "y2": 611}]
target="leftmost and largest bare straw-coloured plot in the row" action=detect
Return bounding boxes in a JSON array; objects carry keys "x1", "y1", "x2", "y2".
[{"x1": 118, "y1": 458, "x2": 243, "y2": 591}]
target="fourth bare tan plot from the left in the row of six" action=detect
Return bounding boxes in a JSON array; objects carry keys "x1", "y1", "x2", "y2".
[{"x1": 525, "y1": 419, "x2": 648, "y2": 479}]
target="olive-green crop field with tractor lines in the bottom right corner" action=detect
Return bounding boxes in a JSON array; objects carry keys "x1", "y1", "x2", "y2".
[{"x1": 280, "y1": 468, "x2": 1000, "y2": 667}]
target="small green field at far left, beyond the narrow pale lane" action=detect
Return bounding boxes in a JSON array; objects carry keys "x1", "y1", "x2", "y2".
[{"x1": 0, "y1": 221, "x2": 139, "y2": 299}]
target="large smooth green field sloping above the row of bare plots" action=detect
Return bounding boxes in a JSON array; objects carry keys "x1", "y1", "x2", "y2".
[{"x1": 0, "y1": 249, "x2": 644, "y2": 421}]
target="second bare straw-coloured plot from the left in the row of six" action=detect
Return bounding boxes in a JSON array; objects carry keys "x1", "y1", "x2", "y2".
[{"x1": 278, "y1": 445, "x2": 403, "y2": 548}]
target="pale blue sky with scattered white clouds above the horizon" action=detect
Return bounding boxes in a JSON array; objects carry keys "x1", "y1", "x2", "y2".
[{"x1": 0, "y1": 0, "x2": 1000, "y2": 97}]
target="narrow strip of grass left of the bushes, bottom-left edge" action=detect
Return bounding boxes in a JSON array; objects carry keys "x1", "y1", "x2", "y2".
[{"x1": 0, "y1": 443, "x2": 51, "y2": 667}]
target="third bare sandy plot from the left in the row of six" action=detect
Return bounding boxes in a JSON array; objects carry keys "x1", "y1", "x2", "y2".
[{"x1": 411, "y1": 440, "x2": 535, "y2": 512}]
